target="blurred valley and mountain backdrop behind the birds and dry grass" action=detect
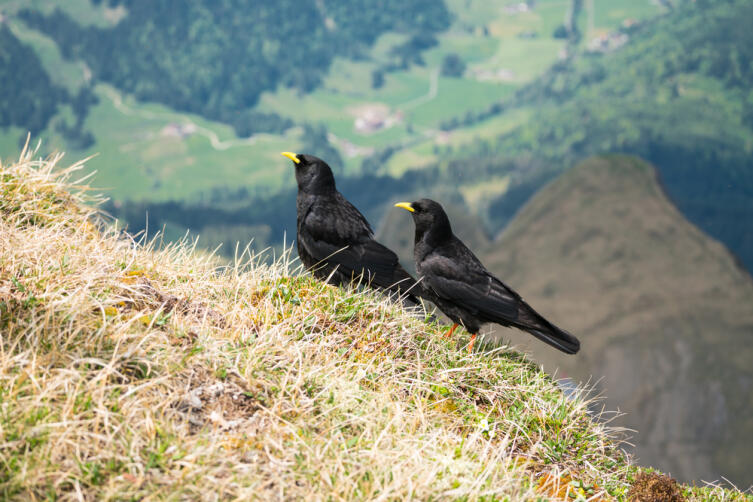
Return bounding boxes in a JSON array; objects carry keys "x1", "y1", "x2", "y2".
[{"x1": 0, "y1": 0, "x2": 753, "y2": 488}]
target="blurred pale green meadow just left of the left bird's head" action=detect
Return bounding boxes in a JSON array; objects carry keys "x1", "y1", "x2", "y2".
[{"x1": 72, "y1": 86, "x2": 299, "y2": 200}]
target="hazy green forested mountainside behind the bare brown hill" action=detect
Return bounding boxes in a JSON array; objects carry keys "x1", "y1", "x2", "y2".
[{"x1": 471, "y1": 0, "x2": 753, "y2": 270}]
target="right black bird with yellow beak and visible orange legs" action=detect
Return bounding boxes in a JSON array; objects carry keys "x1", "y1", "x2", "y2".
[{"x1": 395, "y1": 199, "x2": 580, "y2": 354}]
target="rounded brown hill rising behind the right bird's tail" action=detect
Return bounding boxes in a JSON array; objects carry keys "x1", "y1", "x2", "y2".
[{"x1": 482, "y1": 156, "x2": 753, "y2": 487}]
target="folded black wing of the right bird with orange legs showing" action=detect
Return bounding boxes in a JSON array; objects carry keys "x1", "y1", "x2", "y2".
[{"x1": 421, "y1": 248, "x2": 521, "y2": 324}]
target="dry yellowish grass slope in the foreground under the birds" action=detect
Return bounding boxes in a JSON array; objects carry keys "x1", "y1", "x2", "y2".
[{"x1": 0, "y1": 155, "x2": 741, "y2": 500}]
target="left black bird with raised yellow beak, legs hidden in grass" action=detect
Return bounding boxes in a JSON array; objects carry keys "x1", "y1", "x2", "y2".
[{"x1": 282, "y1": 152, "x2": 421, "y2": 304}]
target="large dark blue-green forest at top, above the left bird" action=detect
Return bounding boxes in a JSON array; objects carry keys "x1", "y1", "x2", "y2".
[{"x1": 20, "y1": 0, "x2": 450, "y2": 136}]
